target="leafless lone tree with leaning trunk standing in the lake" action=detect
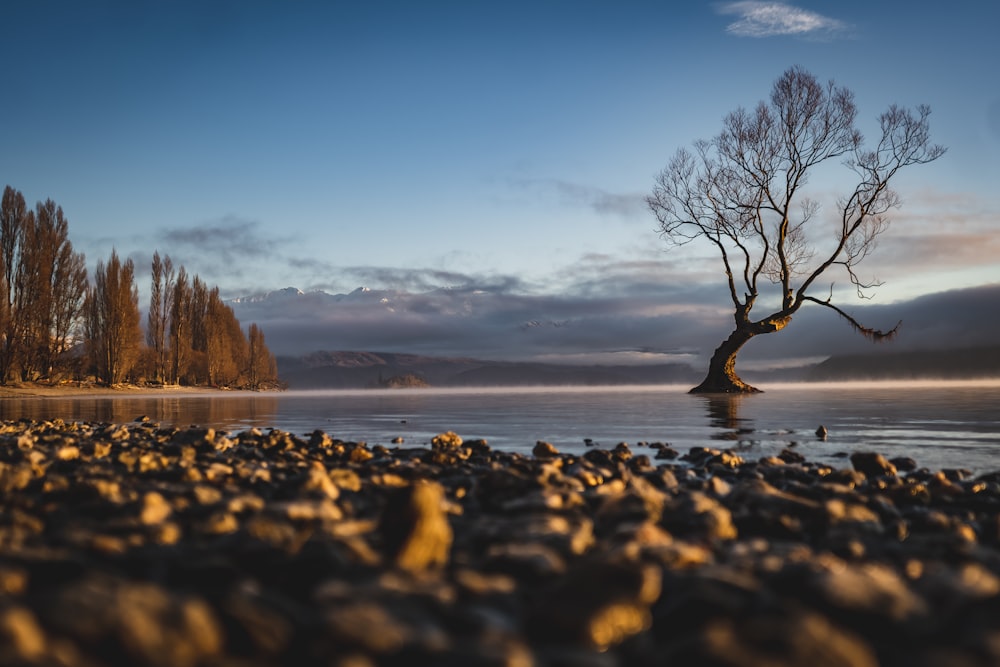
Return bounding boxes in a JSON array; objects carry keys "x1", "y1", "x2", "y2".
[{"x1": 646, "y1": 67, "x2": 945, "y2": 393}]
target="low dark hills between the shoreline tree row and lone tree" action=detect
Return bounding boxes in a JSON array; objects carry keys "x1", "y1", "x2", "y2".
[{"x1": 278, "y1": 352, "x2": 700, "y2": 389}]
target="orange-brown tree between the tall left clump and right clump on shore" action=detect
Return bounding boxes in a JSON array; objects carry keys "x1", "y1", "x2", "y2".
[{"x1": 86, "y1": 250, "x2": 142, "y2": 385}]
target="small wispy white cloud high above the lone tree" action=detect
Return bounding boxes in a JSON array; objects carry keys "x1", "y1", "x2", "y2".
[{"x1": 717, "y1": 1, "x2": 847, "y2": 37}]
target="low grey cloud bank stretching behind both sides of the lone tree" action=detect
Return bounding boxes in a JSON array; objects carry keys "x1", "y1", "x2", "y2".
[{"x1": 233, "y1": 285, "x2": 1000, "y2": 368}]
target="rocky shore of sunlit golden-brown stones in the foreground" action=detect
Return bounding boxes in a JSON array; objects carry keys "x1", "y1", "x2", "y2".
[{"x1": 0, "y1": 420, "x2": 1000, "y2": 667}]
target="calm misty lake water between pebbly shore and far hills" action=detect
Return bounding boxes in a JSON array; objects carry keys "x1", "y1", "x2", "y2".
[{"x1": 0, "y1": 380, "x2": 1000, "y2": 473}]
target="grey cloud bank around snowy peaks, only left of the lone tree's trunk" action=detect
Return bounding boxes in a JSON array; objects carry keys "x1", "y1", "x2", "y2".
[{"x1": 227, "y1": 261, "x2": 731, "y2": 360}]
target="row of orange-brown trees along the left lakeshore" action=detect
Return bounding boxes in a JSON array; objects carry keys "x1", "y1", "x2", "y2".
[{"x1": 0, "y1": 185, "x2": 278, "y2": 389}]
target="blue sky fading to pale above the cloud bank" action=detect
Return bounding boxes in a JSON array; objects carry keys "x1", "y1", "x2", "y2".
[{"x1": 0, "y1": 0, "x2": 1000, "y2": 366}]
